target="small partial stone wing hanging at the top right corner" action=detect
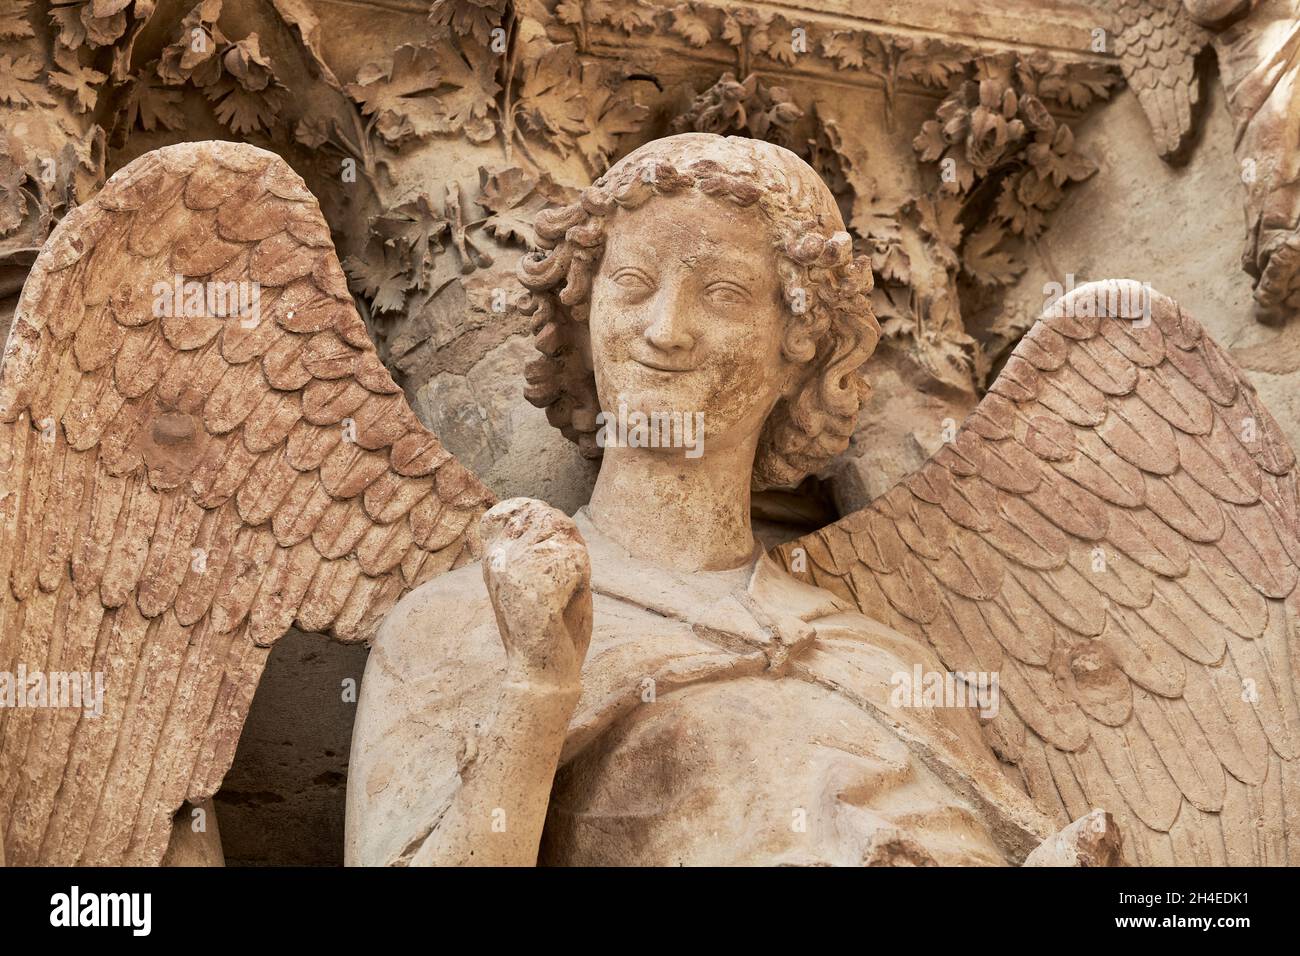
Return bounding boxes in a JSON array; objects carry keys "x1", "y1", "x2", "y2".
[{"x1": 1104, "y1": 0, "x2": 1210, "y2": 159}]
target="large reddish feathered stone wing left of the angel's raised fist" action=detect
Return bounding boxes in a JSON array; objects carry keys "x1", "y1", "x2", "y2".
[{"x1": 0, "y1": 143, "x2": 490, "y2": 865}]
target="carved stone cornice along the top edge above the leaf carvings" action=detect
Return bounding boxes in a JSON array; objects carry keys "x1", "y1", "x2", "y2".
[{"x1": 545, "y1": 0, "x2": 1118, "y2": 114}]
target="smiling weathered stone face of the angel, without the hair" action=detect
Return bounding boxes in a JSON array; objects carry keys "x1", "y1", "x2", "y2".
[{"x1": 590, "y1": 195, "x2": 794, "y2": 447}]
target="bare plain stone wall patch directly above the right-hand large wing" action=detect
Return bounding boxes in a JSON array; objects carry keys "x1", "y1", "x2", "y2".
[{"x1": 976, "y1": 85, "x2": 1300, "y2": 441}]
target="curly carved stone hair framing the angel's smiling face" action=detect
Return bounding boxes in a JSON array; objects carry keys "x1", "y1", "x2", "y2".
[{"x1": 519, "y1": 133, "x2": 880, "y2": 489}]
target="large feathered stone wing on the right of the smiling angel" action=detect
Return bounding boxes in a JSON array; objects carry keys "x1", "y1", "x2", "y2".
[{"x1": 777, "y1": 281, "x2": 1300, "y2": 865}]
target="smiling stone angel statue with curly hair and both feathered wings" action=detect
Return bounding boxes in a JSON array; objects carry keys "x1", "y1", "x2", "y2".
[{"x1": 0, "y1": 134, "x2": 1300, "y2": 865}]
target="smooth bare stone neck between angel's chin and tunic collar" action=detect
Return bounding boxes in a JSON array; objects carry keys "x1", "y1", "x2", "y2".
[{"x1": 588, "y1": 445, "x2": 754, "y2": 571}]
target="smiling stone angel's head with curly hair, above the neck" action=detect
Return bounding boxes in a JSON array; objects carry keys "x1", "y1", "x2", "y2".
[{"x1": 520, "y1": 133, "x2": 879, "y2": 488}]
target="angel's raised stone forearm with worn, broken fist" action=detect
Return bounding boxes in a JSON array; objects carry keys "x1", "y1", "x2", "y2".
[{"x1": 407, "y1": 498, "x2": 592, "y2": 866}]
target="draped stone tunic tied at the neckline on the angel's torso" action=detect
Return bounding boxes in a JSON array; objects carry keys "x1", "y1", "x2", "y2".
[{"x1": 347, "y1": 512, "x2": 1053, "y2": 865}]
